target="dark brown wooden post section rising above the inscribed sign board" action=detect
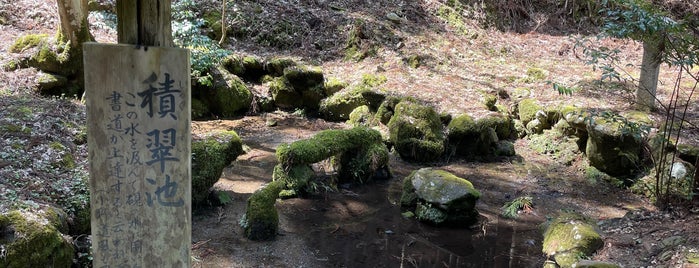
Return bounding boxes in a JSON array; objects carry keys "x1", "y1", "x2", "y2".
[{"x1": 117, "y1": 0, "x2": 174, "y2": 47}]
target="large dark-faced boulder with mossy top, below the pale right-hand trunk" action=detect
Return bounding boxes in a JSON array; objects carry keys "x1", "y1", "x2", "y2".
[{"x1": 585, "y1": 118, "x2": 642, "y2": 176}]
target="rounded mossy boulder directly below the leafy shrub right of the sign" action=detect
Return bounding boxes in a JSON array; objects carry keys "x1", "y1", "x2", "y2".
[{"x1": 204, "y1": 67, "x2": 252, "y2": 117}]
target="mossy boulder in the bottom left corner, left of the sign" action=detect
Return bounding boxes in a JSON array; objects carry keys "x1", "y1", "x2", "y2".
[{"x1": 0, "y1": 210, "x2": 74, "y2": 268}]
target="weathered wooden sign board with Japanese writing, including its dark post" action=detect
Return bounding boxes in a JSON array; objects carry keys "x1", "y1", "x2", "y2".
[{"x1": 83, "y1": 0, "x2": 191, "y2": 267}]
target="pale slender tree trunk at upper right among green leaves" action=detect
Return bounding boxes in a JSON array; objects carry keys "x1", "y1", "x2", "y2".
[{"x1": 636, "y1": 38, "x2": 663, "y2": 111}]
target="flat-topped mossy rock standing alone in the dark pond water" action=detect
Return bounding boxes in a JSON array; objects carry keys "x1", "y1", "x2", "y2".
[{"x1": 400, "y1": 168, "x2": 481, "y2": 227}]
